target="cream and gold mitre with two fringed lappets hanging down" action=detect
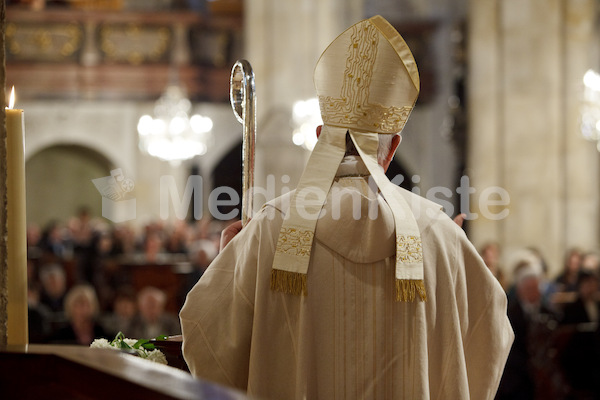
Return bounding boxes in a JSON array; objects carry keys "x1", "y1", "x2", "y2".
[{"x1": 271, "y1": 16, "x2": 426, "y2": 301}]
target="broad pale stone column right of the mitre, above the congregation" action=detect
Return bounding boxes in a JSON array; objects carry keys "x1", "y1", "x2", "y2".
[{"x1": 468, "y1": 0, "x2": 599, "y2": 275}]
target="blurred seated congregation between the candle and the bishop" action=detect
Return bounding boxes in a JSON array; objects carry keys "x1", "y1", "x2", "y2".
[{"x1": 27, "y1": 209, "x2": 223, "y2": 345}]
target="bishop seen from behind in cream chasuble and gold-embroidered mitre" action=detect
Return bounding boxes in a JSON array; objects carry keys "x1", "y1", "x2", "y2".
[{"x1": 180, "y1": 16, "x2": 514, "y2": 399}]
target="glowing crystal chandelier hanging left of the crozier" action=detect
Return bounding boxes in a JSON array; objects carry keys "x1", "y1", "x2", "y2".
[{"x1": 137, "y1": 84, "x2": 213, "y2": 165}]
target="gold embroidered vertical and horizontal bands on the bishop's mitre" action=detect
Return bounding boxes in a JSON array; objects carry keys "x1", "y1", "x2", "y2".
[{"x1": 319, "y1": 24, "x2": 412, "y2": 133}]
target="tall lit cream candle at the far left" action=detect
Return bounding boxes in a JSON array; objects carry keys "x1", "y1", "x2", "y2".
[{"x1": 6, "y1": 87, "x2": 29, "y2": 345}]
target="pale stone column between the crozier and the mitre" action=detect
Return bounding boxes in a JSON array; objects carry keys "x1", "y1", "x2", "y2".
[{"x1": 244, "y1": 0, "x2": 363, "y2": 209}]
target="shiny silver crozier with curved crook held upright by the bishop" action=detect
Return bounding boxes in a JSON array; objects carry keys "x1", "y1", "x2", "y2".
[{"x1": 229, "y1": 60, "x2": 256, "y2": 225}]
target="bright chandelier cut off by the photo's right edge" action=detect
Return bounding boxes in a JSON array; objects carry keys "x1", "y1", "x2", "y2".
[{"x1": 580, "y1": 69, "x2": 600, "y2": 151}]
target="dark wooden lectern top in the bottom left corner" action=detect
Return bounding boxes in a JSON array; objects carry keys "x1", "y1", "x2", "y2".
[{"x1": 0, "y1": 345, "x2": 247, "y2": 400}]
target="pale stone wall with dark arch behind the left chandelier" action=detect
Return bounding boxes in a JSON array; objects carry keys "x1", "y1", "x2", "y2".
[{"x1": 20, "y1": 100, "x2": 242, "y2": 225}]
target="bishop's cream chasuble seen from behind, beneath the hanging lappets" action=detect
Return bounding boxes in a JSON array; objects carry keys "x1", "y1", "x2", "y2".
[{"x1": 180, "y1": 157, "x2": 513, "y2": 400}]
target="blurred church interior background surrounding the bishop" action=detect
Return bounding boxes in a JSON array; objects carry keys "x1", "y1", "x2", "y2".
[{"x1": 0, "y1": 0, "x2": 600, "y2": 399}]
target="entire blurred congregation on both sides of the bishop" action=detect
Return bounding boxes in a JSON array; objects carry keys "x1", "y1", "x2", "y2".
[{"x1": 22, "y1": 209, "x2": 600, "y2": 399}]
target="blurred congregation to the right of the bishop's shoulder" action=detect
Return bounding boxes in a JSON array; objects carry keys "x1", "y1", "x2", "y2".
[{"x1": 480, "y1": 243, "x2": 600, "y2": 399}]
